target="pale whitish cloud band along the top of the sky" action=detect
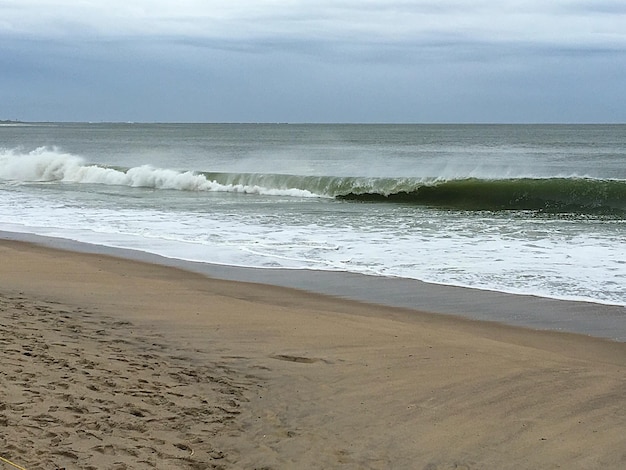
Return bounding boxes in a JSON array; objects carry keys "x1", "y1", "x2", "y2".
[{"x1": 0, "y1": 0, "x2": 626, "y2": 47}]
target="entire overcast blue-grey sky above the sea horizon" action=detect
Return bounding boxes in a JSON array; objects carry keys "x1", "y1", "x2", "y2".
[{"x1": 0, "y1": 0, "x2": 626, "y2": 123}]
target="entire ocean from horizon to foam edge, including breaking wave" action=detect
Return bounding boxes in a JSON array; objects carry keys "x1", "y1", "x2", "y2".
[{"x1": 0, "y1": 123, "x2": 626, "y2": 306}]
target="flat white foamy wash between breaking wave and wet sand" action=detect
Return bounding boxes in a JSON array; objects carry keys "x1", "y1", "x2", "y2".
[{"x1": 0, "y1": 184, "x2": 626, "y2": 305}]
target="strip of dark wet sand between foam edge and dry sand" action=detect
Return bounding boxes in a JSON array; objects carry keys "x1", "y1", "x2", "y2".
[{"x1": 0, "y1": 231, "x2": 626, "y2": 342}]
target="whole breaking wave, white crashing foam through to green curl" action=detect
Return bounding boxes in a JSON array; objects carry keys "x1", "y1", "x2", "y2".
[{"x1": 0, "y1": 147, "x2": 626, "y2": 218}]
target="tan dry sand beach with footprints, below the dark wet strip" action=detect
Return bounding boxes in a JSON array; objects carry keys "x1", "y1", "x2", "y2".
[{"x1": 0, "y1": 241, "x2": 626, "y2": 470}]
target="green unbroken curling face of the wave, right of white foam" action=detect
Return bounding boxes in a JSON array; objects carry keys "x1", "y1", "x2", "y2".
[{"x1": 205, "y1": 173, "x2": 626, "y2": 217}]
